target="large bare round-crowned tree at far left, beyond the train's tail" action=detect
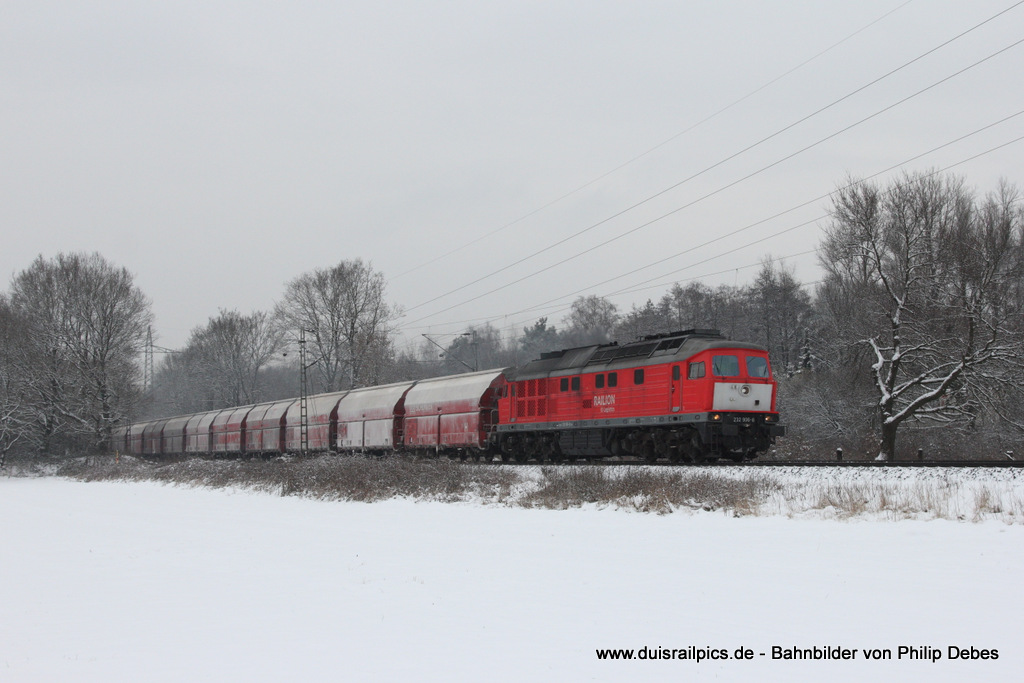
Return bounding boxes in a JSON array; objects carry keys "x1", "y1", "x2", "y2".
[{"x1": 10, "y1": 254, "x2": 153, "y2": 449}]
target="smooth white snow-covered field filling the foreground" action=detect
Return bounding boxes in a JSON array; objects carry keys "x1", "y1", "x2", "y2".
[{"x1": 0, "y1": 478, "x2": 1024, "y2": 683}]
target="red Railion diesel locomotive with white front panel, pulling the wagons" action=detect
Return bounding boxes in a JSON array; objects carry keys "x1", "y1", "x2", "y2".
[{"x1": 498, "y1": 330, "x2": 785, "y2": 462}]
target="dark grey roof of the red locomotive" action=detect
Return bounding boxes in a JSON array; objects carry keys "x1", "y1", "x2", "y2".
[{"x1": 509, "y1": 330, "x2": 765, "y2": 381}]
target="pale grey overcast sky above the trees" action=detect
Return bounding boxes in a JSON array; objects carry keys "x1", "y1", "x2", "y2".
[{"x1": 0, "y1": 0, "x2": 1024, "y2": 346}]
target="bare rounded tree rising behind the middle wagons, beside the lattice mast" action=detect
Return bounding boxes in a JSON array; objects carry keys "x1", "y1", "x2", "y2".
[{"x1": 275, "y1": 259, "x2": 397, "y2": 391}]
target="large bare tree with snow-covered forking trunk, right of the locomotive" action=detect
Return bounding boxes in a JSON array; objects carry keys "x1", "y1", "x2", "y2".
[{"x1": 819, "y1": 174, "x2": 1022, "y2": 460}]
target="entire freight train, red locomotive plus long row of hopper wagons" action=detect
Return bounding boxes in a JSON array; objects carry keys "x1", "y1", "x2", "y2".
[{"x1": 115, "y1": 330, "x2": 785, "y2": 463}]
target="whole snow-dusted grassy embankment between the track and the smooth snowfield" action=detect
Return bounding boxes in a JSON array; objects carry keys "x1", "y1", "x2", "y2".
[{"x1": 14, "y1": 456, "x2": 1024, "y2": 523}]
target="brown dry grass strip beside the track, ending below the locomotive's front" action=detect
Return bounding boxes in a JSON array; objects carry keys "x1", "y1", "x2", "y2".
[{"x1": 51, "y1": 456, "x2": 777, "y2": 514}]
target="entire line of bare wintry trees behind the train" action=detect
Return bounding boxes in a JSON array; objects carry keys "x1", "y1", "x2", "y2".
[{"x1": 0, "y1": 173, "x2": 1024, "y2": 458}]
